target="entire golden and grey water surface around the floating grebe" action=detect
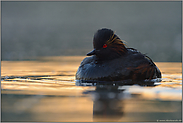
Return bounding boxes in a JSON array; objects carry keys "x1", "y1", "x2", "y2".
[{"x1": 1, "y1": 56, "x2": 182, "y2": 122}]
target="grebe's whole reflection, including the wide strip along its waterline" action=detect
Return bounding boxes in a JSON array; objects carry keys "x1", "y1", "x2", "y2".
[{"x1": 76, "y1": 81, "x2": 155, "y2": 122}]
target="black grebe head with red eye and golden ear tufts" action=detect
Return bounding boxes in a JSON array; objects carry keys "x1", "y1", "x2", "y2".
[{"x1": 87, "y1": 28, "x2": 127, "y2": 60}]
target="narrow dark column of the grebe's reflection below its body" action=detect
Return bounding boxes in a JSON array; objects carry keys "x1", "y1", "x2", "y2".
[{"x1": 91, "y1": 86, "x2": 124, "y2": 120}]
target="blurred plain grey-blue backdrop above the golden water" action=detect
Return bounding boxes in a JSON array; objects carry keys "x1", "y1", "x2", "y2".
[{"x1": 1, "y1": 1, "x2": 182, "y2": 62}]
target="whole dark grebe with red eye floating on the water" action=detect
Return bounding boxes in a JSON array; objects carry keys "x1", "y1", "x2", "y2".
[{"x1": 76, "y1": 28, "x2": 161, "y2": 81}]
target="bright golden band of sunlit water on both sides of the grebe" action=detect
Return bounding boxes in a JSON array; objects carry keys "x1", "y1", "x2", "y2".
[{"x1": 1, "y1": 56, "x2": 182, "y2": 99}]
